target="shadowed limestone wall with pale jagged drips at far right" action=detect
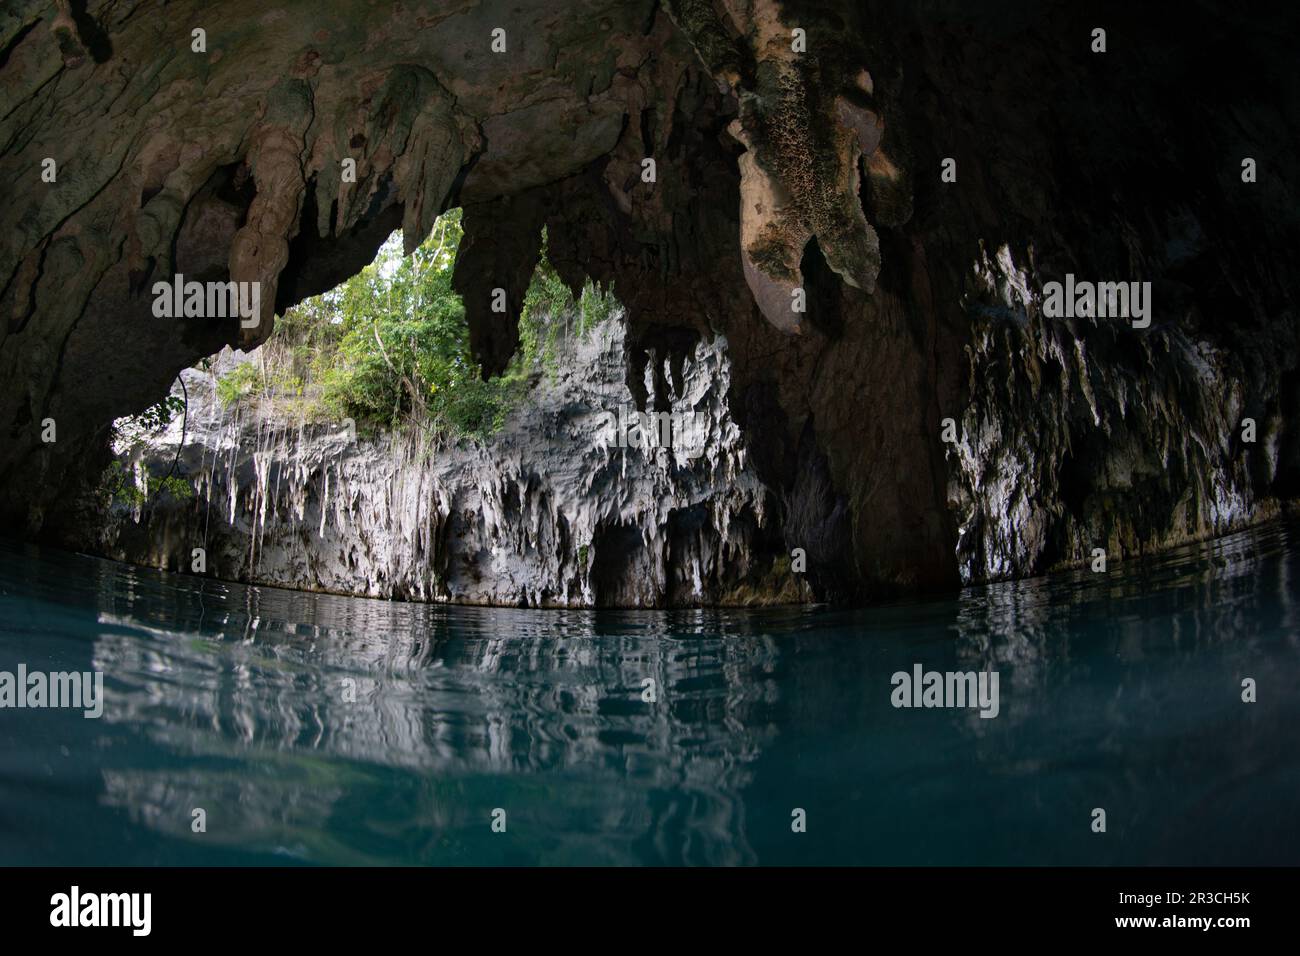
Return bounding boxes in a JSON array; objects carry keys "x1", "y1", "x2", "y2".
[{"x1": 949, "y1": 246, "x2": 1296, "y2": 581}]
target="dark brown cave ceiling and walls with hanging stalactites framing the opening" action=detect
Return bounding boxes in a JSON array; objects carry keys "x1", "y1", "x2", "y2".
[{"x1": 0, "y1": 0, "x2": 1300, "y2": 600}]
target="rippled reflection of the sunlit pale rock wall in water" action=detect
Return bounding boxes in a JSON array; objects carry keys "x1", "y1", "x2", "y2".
[{"x1": 95, "y1": 589, "x2": 777, "y2": 864}]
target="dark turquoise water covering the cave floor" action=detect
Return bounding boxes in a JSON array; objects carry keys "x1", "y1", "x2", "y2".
[{"x1": 0, "y1": 525, "x2": 1300, "y2": 865}]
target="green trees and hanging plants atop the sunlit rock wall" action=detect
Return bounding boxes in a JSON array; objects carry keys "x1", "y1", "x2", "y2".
[{"x1": 217, "y1": 209, "x2": 616, "y2": 441}]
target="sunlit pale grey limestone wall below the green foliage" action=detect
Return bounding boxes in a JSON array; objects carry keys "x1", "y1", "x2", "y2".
[{"x1": 77, "y1": 315, "x2": 811, "y2": 607}]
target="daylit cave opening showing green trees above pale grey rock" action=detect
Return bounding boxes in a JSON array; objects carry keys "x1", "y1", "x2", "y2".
[{"x1": 88, "y1": 209, "x2": 809, "y2": 606}]
